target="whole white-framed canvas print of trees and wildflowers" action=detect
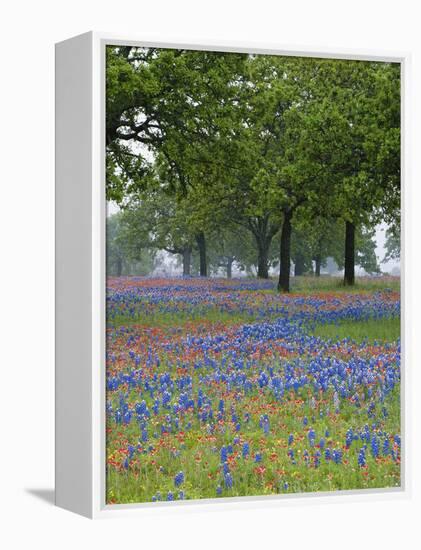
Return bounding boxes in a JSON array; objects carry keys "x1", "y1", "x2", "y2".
[{"x1": 56, "y1": 33, "x2": 407, "y2": 517}]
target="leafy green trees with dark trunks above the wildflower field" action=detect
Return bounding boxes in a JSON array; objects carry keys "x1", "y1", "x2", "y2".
[{"x1": 106, "y1": 47, "x2": 400, "y2": 292}]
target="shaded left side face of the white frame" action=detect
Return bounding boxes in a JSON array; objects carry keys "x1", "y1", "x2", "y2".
[{"x1": 55, "y1": 34, "x2": 94, "y2": 517}]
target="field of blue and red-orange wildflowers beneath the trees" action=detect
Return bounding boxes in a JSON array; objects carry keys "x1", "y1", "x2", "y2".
[{"x1": 106, "y1": 277, "x2": 401, "y2": 504}]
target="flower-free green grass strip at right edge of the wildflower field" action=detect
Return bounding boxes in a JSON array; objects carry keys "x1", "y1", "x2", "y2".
[{"x1": 309, "y1": 317, "x2": 400, "y2": 342}]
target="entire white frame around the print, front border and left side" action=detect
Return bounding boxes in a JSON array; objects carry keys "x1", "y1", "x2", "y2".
[{"x1": 56, "y1": 32, "x2": 411, "y2": 518}]
